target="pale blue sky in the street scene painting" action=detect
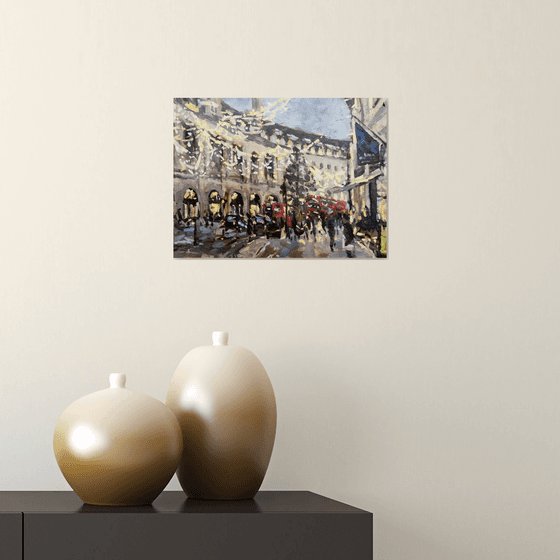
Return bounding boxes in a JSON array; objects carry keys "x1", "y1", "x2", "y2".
[{"x1": 224, "y1": 97, "x2": 350, "y2": 140}]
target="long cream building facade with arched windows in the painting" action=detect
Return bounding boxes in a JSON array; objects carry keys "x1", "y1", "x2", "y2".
[{"x1": 173, "y1": 98, "x2": 351, "y2": 220}]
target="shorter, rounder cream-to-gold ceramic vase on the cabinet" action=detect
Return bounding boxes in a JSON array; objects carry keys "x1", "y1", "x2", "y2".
[{"x1": 53, "y1": 373, "x2": 183, "y2": 506}]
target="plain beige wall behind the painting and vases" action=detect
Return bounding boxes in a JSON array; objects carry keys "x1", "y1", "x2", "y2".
[{"x1": 0, "y1": 0, "x2": 560, "y2": 560}]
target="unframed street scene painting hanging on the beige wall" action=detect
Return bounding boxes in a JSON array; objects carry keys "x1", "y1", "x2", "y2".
[{"x1": 173, "y1": 97, "x2": 388, "y2": 259}]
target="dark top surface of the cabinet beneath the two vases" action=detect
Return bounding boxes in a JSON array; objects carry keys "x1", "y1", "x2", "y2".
[{"x1": 0, "y1": 491, "x2": 369, "y2": 514}]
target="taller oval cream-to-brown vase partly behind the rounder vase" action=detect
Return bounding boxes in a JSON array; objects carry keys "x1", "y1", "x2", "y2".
[{"x1": 166, "y1": 332, "x2": 276, "y2": 500}]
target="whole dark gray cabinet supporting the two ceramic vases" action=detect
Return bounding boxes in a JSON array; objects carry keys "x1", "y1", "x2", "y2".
[{"x1": 0, "y1": 492, "x2": 373, "y2": 560}]
